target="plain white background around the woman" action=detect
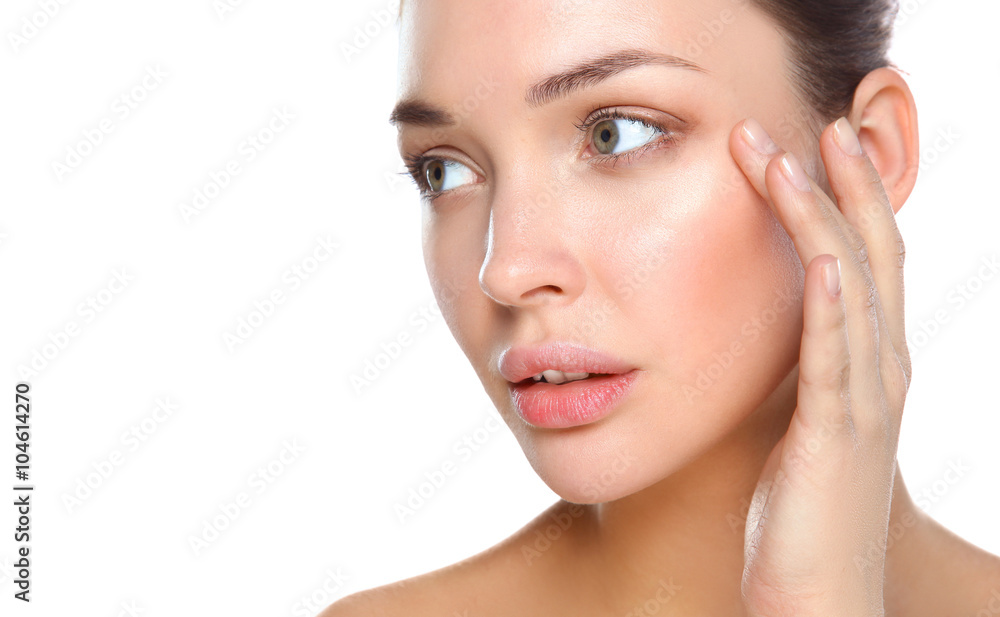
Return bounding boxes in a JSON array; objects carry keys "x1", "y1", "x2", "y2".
[{"x1": 0, "y1": 0, "x2": 1000, "y2": 617}]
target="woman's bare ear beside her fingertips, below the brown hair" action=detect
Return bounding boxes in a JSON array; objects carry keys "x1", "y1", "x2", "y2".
[{"x1": 847, "y1": 68, "x2": 920, "y2": 212}]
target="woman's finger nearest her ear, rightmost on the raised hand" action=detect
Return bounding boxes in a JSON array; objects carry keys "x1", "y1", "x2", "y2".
[{"x1": 820, "y1": 118, "x2": 911, "y2": 384}]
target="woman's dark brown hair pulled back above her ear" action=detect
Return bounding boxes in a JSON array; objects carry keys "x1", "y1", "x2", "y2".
[{"x1": 399, "y1": 0, "x2": 899, "y2": 125}]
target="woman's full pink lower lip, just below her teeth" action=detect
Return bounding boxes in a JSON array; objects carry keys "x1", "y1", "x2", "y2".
[{"x1": 510, "y1": 370, "x2": 638, "y2": 428}]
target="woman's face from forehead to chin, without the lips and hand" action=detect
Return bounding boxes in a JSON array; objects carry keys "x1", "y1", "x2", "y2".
[{"x1": 397, "y1": 0, "x2": 822, "y2": 503}]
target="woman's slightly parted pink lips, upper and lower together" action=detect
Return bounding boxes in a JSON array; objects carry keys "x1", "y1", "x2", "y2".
[{"x1": 499, "y1": 343, "x2": 639, "y2": 428}]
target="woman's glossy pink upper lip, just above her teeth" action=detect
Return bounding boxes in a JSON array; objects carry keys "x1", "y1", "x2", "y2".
[{"x1": 498, "y1": 343, "x2": 635, "y2": 383}]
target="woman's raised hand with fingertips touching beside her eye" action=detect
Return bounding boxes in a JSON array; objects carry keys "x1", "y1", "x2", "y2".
[{"x1": 730, "y1": 119, "x2": 911, "y2": 617}]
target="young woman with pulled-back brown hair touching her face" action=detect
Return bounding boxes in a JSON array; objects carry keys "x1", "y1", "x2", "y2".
[{"x1": 324, "y1": 0, "x2": 1000, "y2": 617}]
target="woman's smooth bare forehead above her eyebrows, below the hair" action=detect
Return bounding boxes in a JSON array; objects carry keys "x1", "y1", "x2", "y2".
[{"x1": 398, "y1": 0, "x2": 785, "y2": 108}]
